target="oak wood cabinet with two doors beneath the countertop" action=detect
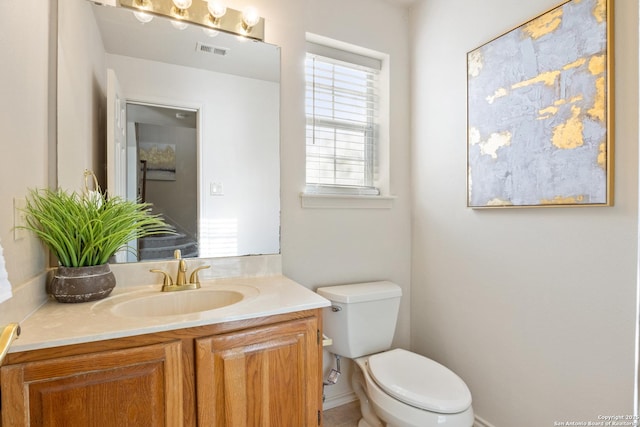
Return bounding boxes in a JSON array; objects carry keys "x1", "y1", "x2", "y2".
[{"x1": 0, "y1": 309, "x2": 322, "y2": 427}]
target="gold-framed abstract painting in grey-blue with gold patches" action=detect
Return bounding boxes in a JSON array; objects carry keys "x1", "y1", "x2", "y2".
[{"x1": 467, "y1": 0, "x2": 613, "y2": 208}]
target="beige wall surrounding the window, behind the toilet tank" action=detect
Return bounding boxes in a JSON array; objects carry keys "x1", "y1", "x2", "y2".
[{"x1": 252, "y1": 0, "x2": 411, "y2": 402}]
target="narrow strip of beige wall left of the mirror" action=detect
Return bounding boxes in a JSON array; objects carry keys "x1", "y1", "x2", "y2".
[{"x1": 0, "y1": 0, "x2": 55, "y2": 323}]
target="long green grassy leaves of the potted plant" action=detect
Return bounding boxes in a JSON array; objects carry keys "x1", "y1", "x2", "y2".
[{"x1": 21, "y1": 172, "x2": 172, "y2": 267}]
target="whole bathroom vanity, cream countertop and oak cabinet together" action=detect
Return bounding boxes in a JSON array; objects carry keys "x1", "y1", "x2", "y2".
[{"x1": 0, "y1": 276, "x2": 328, "y2": 426}]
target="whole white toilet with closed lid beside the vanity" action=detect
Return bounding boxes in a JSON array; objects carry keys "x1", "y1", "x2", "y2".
[{"x1": 317, "y1": 281, "x2": 474, "y2": 427}]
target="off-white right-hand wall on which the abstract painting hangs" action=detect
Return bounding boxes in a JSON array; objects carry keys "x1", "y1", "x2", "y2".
[{"x1": 411, "y1": 0, "x2": 638, "y2": 427}]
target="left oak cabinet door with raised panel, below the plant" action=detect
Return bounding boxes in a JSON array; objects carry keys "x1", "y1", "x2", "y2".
[{"x1": 0, "y1": 341, "x2": 183, "y2": 427}]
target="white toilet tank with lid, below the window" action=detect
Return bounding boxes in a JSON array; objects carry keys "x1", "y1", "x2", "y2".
[{"x1": 316, "y1": 281, "x2": 402, "y2": 359}]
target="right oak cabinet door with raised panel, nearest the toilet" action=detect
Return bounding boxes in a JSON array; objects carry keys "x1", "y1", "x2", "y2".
[{"x1": 196, "y1": 317, "x2": 321, "y2": 427}]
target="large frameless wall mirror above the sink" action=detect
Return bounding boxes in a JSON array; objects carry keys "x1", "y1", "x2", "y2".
[{"x1": 57, "y1": 0, "x2": 280, "y2": 261}]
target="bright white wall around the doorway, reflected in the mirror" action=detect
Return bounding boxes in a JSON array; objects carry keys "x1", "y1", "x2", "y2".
[{"x1": 107, "y1": 55, "x2": 280, "y2": 256}]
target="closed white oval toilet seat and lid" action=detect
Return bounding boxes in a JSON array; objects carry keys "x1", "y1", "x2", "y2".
[{"x1": 367, "y1": 349, "x2": 471, "y2": 414}]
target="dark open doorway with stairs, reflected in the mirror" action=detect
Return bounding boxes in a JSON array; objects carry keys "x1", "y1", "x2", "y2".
[{"x1": 123, "y1": 103, "x2": 198, "y2": 261}]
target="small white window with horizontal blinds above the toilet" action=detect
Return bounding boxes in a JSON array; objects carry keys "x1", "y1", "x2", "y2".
[{"x1": 305, "y1": 43, "x2": 381, "y2": 195}]
